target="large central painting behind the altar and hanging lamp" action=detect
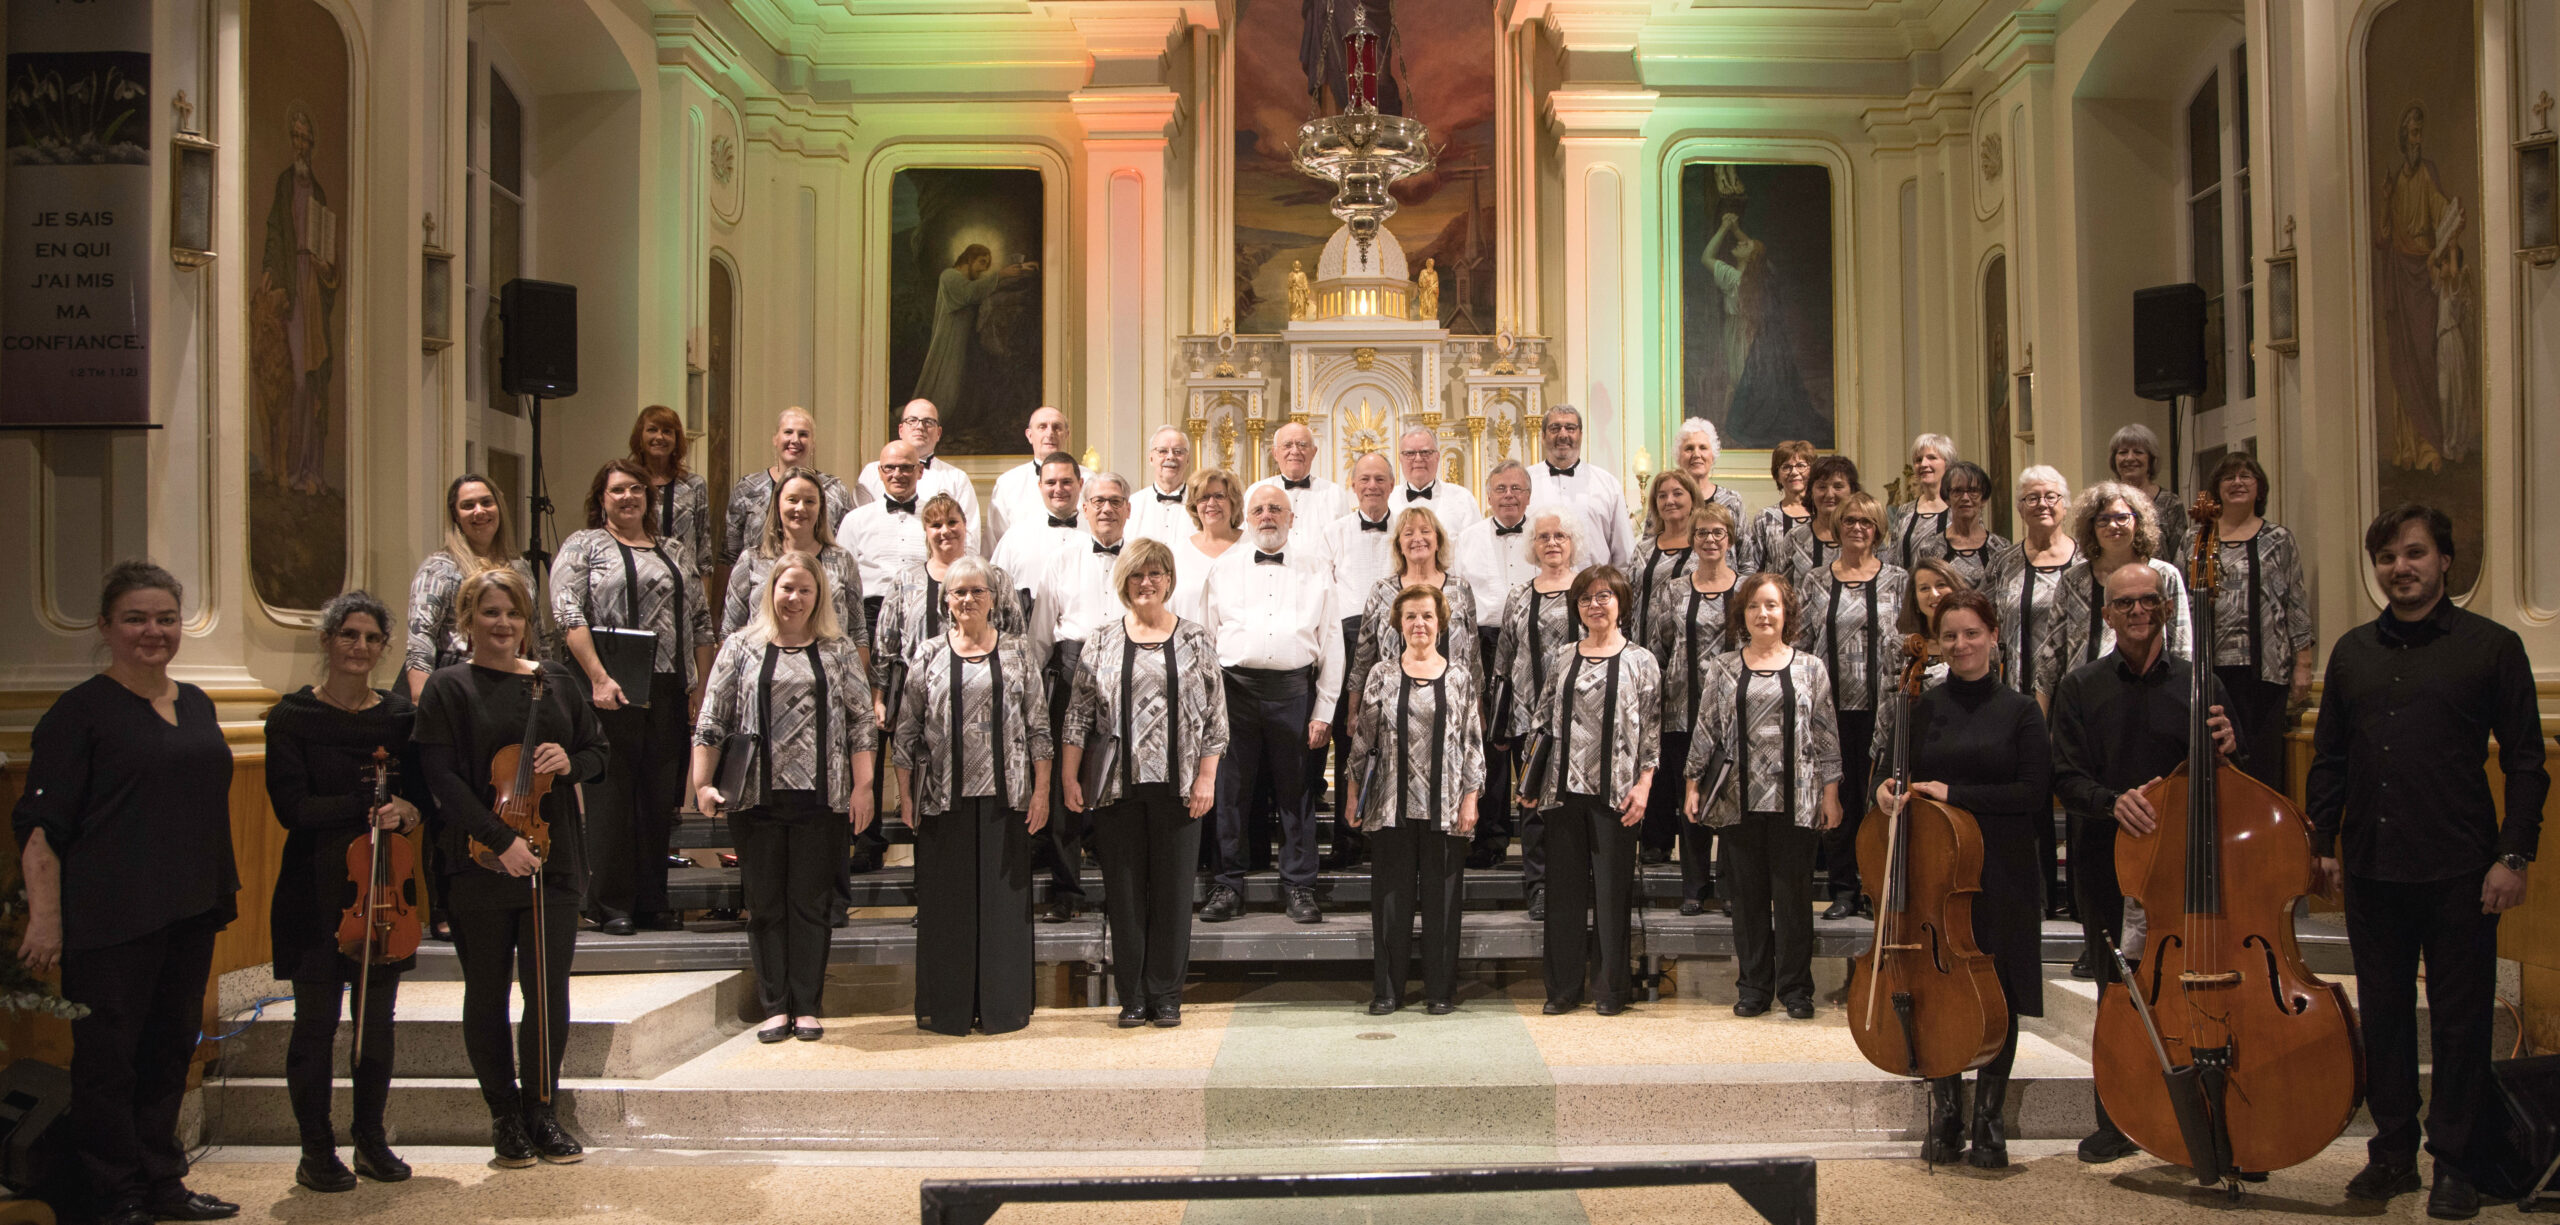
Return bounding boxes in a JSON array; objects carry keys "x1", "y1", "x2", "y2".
[{"x1": 1231, "y1": 0, "x2": 1498, "y2": 335}]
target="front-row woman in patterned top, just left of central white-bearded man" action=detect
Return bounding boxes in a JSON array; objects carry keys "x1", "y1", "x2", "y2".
[{"x1": 1057, "y1": 542, "x2": 1226, "y2": 1028}]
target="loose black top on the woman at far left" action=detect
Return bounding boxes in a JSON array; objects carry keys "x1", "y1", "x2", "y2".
[{"x1": 10, "y1": 673, "x2": 241, "y2": 951}]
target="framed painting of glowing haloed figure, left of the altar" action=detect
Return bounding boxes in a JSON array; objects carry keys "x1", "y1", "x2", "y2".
[{"x1": 886, "y1": 166, "x2": 1044, "y2": 455}]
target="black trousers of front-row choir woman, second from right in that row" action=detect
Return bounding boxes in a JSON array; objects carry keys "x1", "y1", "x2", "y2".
[{"x1": 1546, "y1": 790, "x2": 1636, "y2": 1005}]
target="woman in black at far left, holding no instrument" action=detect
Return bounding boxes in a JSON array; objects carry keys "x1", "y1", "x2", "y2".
[{"x1": 10, "y1": 563, "x2": 241, "y2": 1225}]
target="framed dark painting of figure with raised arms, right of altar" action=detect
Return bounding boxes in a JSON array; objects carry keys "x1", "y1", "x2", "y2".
[{"x1": 1679, "y1": 161, "x2": 1833, "y2": 450}]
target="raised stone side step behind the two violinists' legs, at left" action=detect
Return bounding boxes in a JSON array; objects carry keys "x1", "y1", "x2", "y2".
[{"x1": 215, "y1": 971, "x2": 755, "y2": 1082}]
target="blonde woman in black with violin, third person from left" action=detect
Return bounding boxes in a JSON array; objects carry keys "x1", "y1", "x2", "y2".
[{"x1": 417, "y1": 570, "x2": 604, "y2": 1169}]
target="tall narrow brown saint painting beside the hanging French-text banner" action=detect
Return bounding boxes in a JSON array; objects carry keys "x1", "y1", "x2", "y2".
[{"x1": 241, "y1": 0, "x2": 356, "y2": 609}]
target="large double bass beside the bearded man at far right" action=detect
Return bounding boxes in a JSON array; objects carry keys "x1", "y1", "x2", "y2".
[{"x1": 2089, "y1": 491, "x2": 2365, "y2": 1194}]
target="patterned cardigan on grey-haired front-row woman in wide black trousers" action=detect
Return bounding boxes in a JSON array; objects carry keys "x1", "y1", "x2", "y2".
[{"x1": 891, "y1": 634, "x2": 1055, "y2": 816}]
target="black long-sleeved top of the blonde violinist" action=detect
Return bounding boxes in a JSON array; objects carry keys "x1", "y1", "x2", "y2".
[{"x1": 417, "y1": 662, "x2": 607, "y2": 900}]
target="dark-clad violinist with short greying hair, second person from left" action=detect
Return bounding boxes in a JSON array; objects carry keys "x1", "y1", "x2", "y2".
[{"x1": 266, "y1": 591, "x2": 425, "y2": 1192}]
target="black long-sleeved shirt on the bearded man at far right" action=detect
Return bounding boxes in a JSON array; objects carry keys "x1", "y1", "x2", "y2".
[{"x1": 2307, "y1": 598, "x2": 2552, "y2": 882}]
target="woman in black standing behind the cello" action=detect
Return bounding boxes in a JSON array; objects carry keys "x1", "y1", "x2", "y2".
[{"x1": 1876, "y1": 591, "x2": 2053, "y2": 1169}]
